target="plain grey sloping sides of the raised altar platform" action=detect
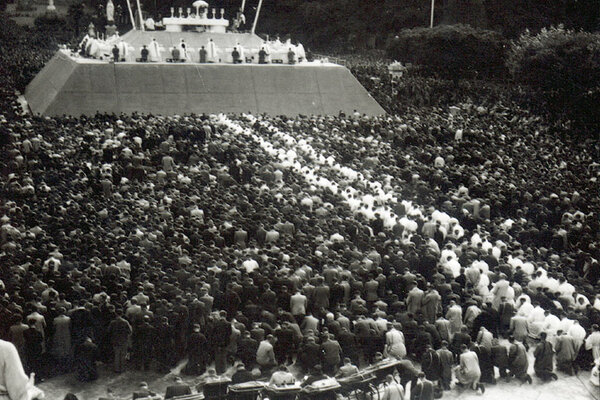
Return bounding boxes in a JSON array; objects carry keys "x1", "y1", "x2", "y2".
[{"x1": 25, "y1": 51, "x2": 385, "y2": 116}]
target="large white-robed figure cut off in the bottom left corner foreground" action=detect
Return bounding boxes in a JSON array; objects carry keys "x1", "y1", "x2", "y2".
[{"x1": 0, "y1": 340, "x2": 44, "y2": 400}]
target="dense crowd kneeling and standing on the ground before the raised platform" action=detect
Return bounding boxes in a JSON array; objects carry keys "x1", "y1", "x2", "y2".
[{"x1": 0, "y1": 14, "x2": 600, "y2": 399}]
